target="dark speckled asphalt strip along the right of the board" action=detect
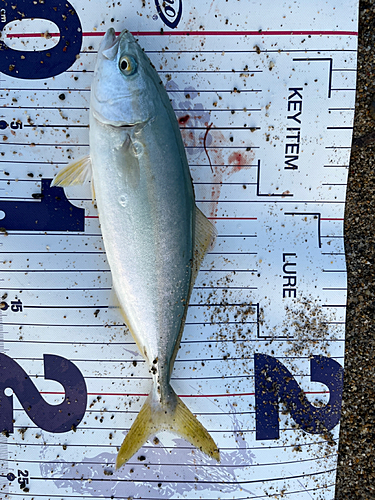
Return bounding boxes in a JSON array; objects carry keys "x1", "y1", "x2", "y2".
[{"x1": 336, "y1": 0, "x2": 375, "y2": 500}]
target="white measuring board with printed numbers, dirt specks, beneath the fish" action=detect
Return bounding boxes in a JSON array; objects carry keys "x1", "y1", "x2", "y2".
[{"x1": 0, "y1": 0, "x2": 358, "y2": 500}]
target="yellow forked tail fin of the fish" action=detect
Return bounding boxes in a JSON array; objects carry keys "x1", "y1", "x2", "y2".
[{"x1": 116, "y1": 387, "x2": 220, "y2": 469}]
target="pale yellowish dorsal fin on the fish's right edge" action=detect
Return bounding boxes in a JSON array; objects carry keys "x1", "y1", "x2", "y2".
[{"x1": 190, "y1": 207, "x2": 217, "y2": 293}]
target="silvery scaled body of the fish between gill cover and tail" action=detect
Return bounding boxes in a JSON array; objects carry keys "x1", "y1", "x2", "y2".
[{"x1": 90, "y1": 96, "x2": 194, "y2": 371}]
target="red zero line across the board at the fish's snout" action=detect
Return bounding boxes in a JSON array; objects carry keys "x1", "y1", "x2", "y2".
[{"x1": 7, "y1": 30, "x2": 358, "y2": 38}]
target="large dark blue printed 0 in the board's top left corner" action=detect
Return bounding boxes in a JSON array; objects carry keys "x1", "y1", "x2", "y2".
[{"x1": 0, "y1": 0, "x2": 82, "y2": 80}]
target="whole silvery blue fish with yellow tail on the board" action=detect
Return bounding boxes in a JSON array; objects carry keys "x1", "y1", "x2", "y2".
[{"x1": 51, "y1": 28, "x2": 220, "y2": 469}]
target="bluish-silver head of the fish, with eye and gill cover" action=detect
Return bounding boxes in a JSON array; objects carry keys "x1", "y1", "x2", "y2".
[{"x1": 91, "y1": 28, "x2": 160, "y2": 127}]
